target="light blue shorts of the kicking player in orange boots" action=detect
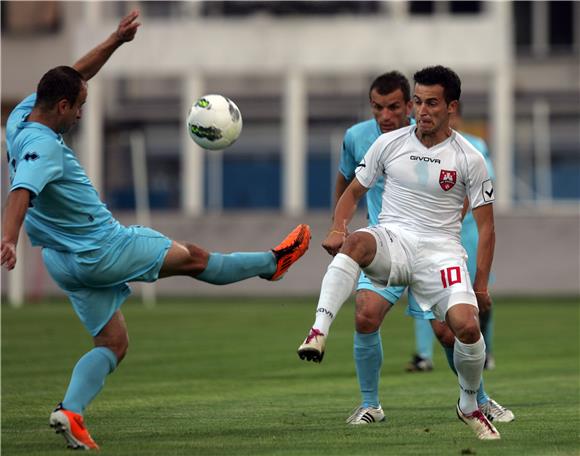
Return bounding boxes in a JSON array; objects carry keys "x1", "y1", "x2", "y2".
[{"x1": 42, "y1": 226, "x2": 171, "y2": 337}]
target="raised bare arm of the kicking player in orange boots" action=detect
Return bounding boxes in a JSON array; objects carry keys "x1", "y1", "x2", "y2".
[{"x1": 73, "y1": 11, "x2": 141, "y2": 81}]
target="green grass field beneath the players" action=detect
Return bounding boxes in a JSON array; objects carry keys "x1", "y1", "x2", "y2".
[{"x1": 2, "y1": 299, "x2": 580, "y2": 456}]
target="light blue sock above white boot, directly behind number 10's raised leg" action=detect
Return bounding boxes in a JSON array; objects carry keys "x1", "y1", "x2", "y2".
[{"x1": 354, "y1": 331, "x2": 383, "y2": 407}]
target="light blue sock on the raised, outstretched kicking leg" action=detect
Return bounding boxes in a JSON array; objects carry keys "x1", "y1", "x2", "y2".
[{"x1": 195, "y1": 252, "x2": 276, "y2": 285}]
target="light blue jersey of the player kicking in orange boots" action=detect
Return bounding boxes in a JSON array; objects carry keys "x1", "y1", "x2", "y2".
[{"x1": 6, "y1": 94, "x2": 120, "y2": 253}]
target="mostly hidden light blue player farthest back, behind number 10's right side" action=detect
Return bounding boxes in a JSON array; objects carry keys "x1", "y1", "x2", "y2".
[{"x1": 406, "y1": 103, "x2": 495, "y2": 372}]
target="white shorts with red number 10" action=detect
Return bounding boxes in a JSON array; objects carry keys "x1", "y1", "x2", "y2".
[{"x1": 358, "y1": 225, "x2": 477, "y2": 320}]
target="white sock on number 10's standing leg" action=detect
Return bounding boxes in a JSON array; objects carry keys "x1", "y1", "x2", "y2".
[{"x1": 453, "y1": 334, "x2": 485, "y2": 415}]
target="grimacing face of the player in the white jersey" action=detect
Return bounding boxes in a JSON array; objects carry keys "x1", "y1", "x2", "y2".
[{"x1": 413, "y1": 84, "x2": 457, "y2": 135}]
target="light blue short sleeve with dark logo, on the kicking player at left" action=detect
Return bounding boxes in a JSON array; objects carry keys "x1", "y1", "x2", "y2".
[{"x1": 11, "y1": 139, "x2": 63, "y2": 195}]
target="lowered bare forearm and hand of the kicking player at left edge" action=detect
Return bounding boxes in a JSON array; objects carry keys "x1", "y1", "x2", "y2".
[{"x1": 1, "y1": 188, "x2": 30, "y2": 270}]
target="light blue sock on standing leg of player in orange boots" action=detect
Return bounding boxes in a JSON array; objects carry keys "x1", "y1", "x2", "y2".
[{"x1": 62, "y1": 347, "x2": 117, "y2": 415}]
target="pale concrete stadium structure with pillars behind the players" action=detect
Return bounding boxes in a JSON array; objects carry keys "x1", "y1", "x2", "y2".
[{"x1": 2, "y1": 2, "x2": 580, "y2": 302}]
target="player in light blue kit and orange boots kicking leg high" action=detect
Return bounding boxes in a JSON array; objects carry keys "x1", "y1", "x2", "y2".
[{"x1": 1, "y1": 12, "x2": 310, "y2": 450}]
